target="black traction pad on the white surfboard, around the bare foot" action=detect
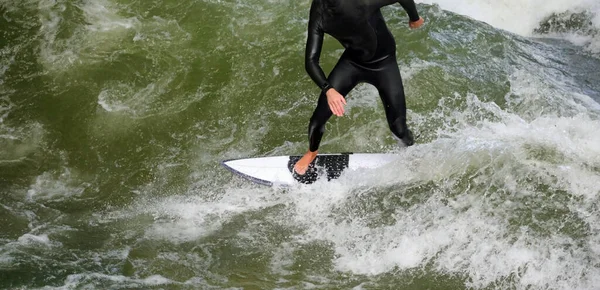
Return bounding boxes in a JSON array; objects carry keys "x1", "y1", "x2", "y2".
[{"x1": 288, "y1": 153, "x2": 352, "y2": 184}]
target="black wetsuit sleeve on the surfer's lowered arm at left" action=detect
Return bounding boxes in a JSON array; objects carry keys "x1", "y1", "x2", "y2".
[{"x1": 304, "y1": 1, "x2": 331, "y2": 92}]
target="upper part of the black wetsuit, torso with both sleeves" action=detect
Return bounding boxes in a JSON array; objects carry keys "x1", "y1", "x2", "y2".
[{"x1": 305, "y1": 0, "x2": 419, "y2": 90}]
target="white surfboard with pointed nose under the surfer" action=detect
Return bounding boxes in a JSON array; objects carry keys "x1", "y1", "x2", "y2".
[{"x1": 222, "y1": 153, "x2": 398, "y2": 186}]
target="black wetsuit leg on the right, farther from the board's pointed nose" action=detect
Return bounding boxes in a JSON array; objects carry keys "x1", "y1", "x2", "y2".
[{"x1": 369, "y1": 55, "x2": 414, "y2": 146}]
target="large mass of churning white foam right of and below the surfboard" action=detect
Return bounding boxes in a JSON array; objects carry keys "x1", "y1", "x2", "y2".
[{"x1": 258, "y1": 84, "x2": 600, "y2": 289}]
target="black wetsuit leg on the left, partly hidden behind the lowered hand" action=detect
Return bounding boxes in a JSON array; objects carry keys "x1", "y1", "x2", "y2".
[{"x1": 308, "y1": 55, "x2": 361, "y2": 152}]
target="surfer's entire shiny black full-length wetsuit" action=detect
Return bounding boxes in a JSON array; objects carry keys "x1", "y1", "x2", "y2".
[{"x1": 305, "y1": 0, "x2": 419, "y2": 151}]
